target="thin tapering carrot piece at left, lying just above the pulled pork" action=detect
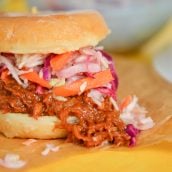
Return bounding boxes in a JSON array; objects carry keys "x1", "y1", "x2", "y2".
[{"x1": 20, "y1": 72, "x2": 51, "y2": 88}]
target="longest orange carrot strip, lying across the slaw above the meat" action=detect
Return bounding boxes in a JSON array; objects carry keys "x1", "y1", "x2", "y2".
[{"x1": 53, "y1": 69, "x2": 114, "y2": 97}]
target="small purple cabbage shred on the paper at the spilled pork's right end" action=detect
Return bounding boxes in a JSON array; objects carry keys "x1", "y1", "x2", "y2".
[{"x1": 126, "y1": 124, "x2": 140, "y2": 146}]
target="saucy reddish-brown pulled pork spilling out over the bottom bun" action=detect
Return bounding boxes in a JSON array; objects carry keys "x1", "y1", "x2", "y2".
[{"x1": 0, "y1": 77, "x2": 130, "y2": 147}]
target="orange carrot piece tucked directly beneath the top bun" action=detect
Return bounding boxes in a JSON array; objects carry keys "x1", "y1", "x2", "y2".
[{"x1": 50, "y1": 52, "x2": 73, "y2": 70}]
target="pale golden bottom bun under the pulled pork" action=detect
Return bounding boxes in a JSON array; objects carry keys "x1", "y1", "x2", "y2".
[{"x1": 0, "y1": 113, "x2": 67, "y2": 139}]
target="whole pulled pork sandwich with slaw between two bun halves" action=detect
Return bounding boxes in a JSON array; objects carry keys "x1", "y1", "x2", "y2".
[{"x1": 0, "y1": 11, "x2": 153, "y2": 147}]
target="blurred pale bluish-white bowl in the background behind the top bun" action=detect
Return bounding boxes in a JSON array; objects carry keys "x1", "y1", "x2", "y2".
[{"x1": 100, "y1": 0, "x2": 172, "y2": 52}]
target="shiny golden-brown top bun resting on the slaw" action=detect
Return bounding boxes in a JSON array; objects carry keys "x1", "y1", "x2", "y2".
[{"x1": 0, "y1": 11, "x2": 109, "y2": 54}]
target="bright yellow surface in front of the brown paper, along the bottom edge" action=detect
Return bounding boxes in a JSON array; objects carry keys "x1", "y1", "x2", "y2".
[{"x1": 28, "y1": 142, "x2": 172, "y2": 172}]
